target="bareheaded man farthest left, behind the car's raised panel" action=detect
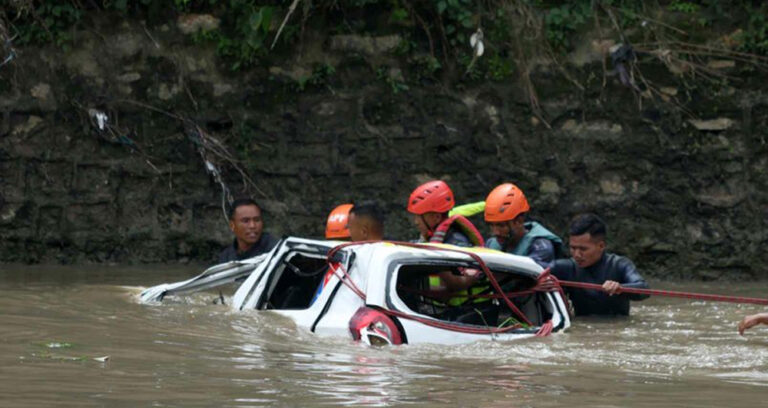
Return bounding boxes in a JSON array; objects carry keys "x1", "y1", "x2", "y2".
[{"x1": 219, "y1": 198, "x2": 277, "y2": 263}]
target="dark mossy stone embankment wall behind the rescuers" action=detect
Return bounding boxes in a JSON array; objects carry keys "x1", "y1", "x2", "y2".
[{"x1": 0, "y1": 3, "x2": 768, "y2": 280}]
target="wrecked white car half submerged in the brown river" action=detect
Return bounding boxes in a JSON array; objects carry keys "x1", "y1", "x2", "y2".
[{"x1": 141, "y1": 237, "x2": 570, "y2": 345}]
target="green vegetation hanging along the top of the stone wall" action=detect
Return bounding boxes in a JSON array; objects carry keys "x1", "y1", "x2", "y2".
[{"x1": 0, "y1": 0, "x2": 768, "y2": 79}]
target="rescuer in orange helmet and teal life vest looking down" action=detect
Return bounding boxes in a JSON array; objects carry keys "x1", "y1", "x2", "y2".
[{"x1": 485, "y1": 183, "x2": 565, "y2": 268}]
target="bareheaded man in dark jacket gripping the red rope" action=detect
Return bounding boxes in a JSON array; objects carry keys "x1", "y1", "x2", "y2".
[{"x1": 552, "y1": 214, "x2": 648, "y2": 316}]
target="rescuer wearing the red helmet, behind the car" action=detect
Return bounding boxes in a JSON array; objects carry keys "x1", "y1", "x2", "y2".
[{"x1": 408, "y1": 180, "x2": 484, "y2": 247}]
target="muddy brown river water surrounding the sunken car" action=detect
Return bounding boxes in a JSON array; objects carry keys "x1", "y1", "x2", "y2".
[{"x1": 0, "y1": 265, "x2": 768, "y2": 407}]
